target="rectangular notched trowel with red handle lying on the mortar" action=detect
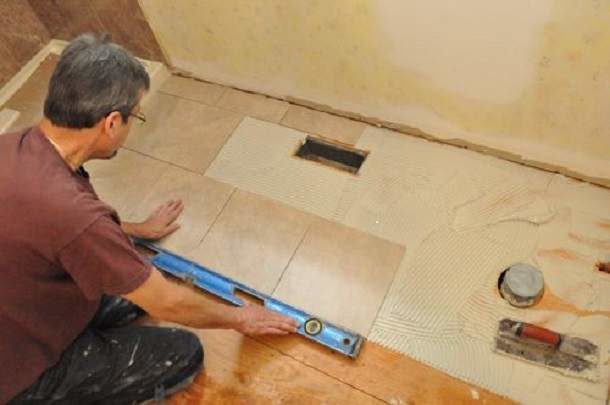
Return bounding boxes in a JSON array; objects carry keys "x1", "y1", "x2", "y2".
[{"x1": 495, "y1": 319, "x2": 600, "y2": 382}]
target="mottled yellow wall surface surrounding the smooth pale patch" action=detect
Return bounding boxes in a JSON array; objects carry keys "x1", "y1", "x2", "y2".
[{"x1": 141, "y1": 0, "x2": 610, "y2": 174}]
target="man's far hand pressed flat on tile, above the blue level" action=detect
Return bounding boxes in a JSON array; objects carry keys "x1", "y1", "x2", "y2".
[{"x1": 122, "y1": 200, "x2": 184, "y2": 240}]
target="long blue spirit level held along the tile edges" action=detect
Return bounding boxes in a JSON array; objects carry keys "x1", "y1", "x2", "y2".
[{"x1": 137, "y1": 240, "x2": 363, "y2": 358}]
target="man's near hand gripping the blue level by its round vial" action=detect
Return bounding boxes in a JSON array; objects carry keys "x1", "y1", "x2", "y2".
[{"x1": 234, "y1": 303, "x2": 299, "y2": 336}]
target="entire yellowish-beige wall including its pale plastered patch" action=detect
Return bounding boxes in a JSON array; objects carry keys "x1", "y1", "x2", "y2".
[{"x1": 140, "y1": 0, "x2": 610, "y2": 183}]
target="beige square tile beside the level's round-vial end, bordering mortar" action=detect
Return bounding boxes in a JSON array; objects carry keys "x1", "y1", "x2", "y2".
[{"x1": 274, "y1": 219, "x2": 404, "y2": 336}]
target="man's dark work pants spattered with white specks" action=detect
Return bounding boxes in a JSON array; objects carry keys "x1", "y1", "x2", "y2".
[{"x1": 10, "y1": 297, "x2": 203, "y2": 404}]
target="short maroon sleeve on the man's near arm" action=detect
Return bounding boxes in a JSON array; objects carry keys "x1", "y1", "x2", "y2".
[{"x1": 58, "y1": 216, "x2": 151, "y2": 300}]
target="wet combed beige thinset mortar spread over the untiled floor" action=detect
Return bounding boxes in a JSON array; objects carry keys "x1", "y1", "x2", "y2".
[{"x1": 206, "y1": 119, "x2": 610, "y2": 404}]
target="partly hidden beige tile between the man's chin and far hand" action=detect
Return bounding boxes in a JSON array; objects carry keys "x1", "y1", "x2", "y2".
[{"x1": 85, "y1": 149, "x2": 169, "y2": 219}]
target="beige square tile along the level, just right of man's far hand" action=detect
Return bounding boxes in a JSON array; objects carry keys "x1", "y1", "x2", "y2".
[{"x1": 189, "y1": 190, "x2": 314, "y2": 294}]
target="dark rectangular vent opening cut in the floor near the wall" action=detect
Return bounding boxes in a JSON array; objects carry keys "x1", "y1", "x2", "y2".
[{"x1": 295, "y1": 136, "x2": 369, "y2": 174}]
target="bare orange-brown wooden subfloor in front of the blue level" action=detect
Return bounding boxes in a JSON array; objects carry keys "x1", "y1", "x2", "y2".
[{"x1": 169, "y1": 330, "x2": 511, "y2": 404}]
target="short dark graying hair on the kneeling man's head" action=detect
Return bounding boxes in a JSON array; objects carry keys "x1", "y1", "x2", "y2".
[{"x1": 44, "y1": 34, "x2": 150, "y2": 128}]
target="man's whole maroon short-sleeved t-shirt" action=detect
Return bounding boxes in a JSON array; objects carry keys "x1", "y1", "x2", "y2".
[{"x1": 0, "y1": 127, "x2": 150, "y2": 403}]
